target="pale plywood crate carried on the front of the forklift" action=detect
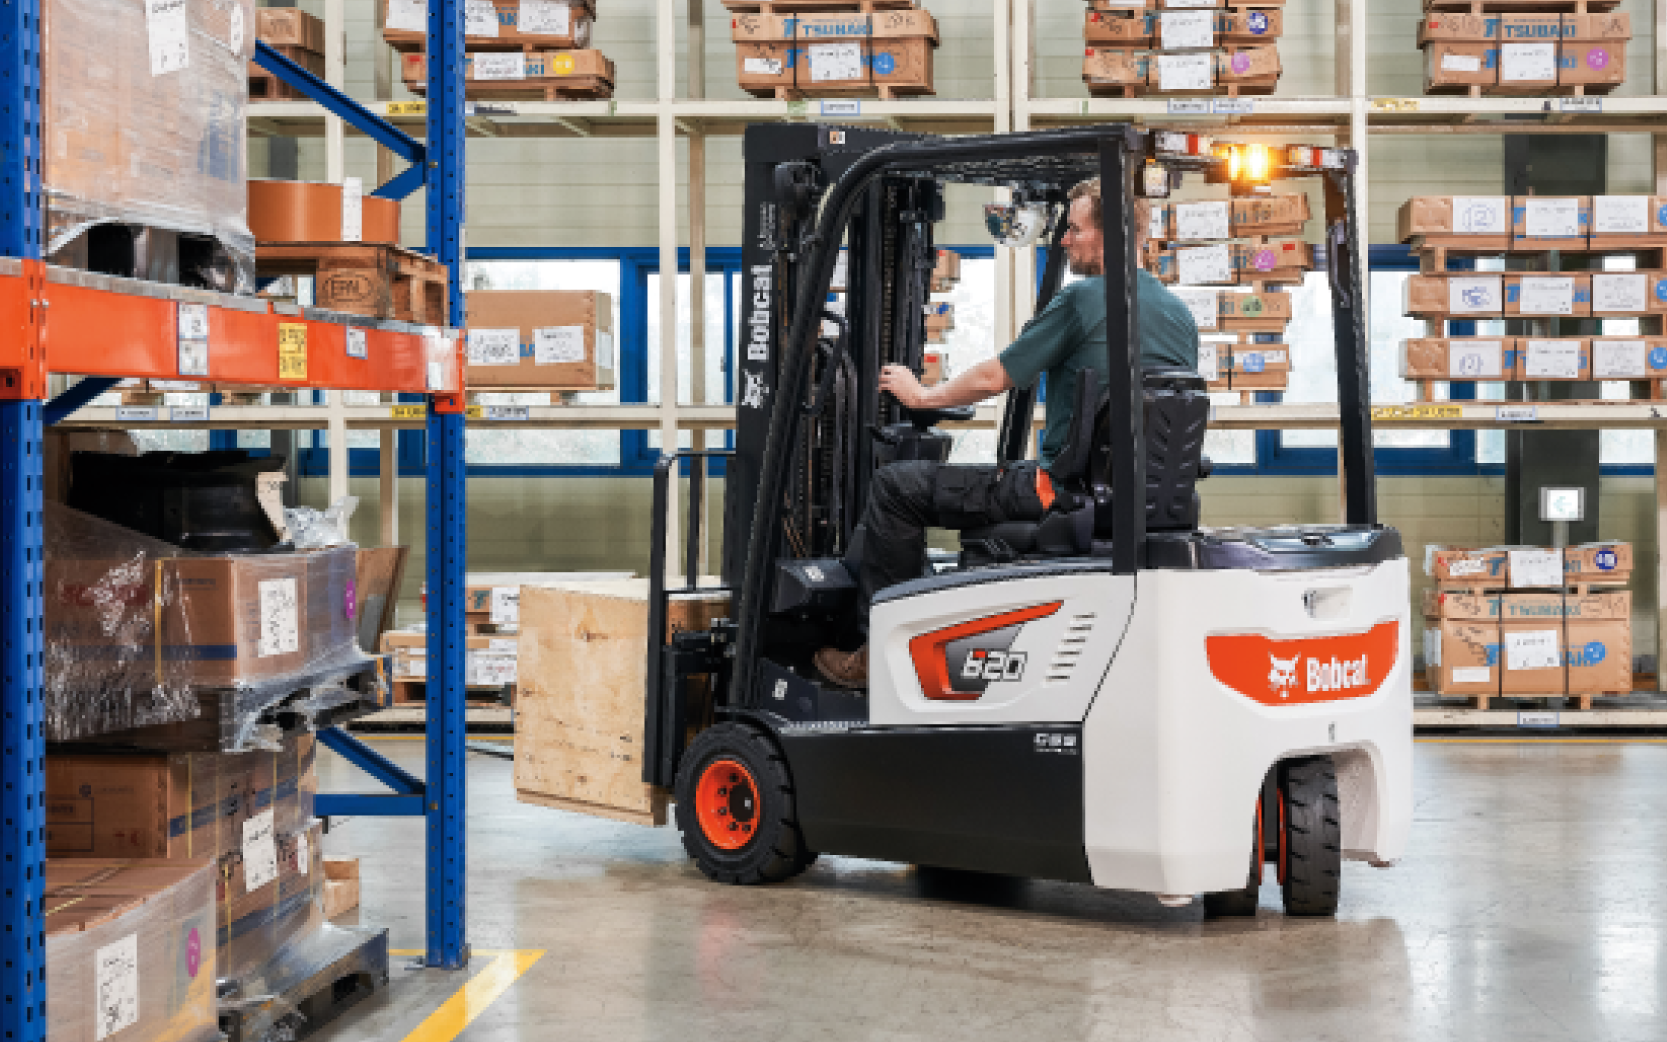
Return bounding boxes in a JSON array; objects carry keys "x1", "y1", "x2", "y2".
[{"x1": 515, "y1": 579, "x2": 728, "y2": 825}]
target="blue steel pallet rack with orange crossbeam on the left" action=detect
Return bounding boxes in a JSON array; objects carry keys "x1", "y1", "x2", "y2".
[{"x1": 0, "y1": 0, "x2": 468, "y2": 1042}]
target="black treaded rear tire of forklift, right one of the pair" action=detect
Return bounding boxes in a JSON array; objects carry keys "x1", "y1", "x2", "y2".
[{"x1": 1279, "y1": 757, "x2": 1344, "y2": 915}]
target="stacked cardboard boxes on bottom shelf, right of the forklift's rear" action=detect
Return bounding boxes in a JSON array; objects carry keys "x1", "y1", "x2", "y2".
[{"x1": 1424, "y1": 544, "x2": 1632, "y2": 709}]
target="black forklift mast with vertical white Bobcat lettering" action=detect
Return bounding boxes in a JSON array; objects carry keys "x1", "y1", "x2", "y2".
[{"x1": 722, "y1": 123, "x2": 944, "y2": 585}]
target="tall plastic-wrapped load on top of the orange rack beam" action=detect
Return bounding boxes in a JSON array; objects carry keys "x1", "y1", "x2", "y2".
[{"x1": 42, "y1": 0, "x2": 255, "y2": 280}]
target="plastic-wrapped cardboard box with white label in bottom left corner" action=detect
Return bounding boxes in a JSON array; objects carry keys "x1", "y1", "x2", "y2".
[{"x1": 42, "y1": 859, "x2": 220, "y2": 1042}]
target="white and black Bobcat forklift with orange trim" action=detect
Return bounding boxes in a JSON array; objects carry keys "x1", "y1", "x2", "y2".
[{"x1": 643, "y1": 125, "x2": 1412, "y2": 915}]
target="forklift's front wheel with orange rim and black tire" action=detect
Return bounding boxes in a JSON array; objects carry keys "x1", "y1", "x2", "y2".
[{"x1": 675, "y1": 724, "x2": 815, "y2": 887}]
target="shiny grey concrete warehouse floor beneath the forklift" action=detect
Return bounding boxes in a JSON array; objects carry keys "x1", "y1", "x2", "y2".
[{"x1": 320, "y1": 742, "x2": 1667, "y2": 1042}]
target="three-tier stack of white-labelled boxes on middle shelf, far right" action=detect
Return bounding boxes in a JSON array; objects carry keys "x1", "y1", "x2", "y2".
[{"x1": 1399, "y1": 195, "x2": 1667, "y2": 400}]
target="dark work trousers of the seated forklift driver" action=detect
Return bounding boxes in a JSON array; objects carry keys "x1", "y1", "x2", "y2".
[{"x1": 860, "y1": 460, "x2": 1047, "y2": 604}]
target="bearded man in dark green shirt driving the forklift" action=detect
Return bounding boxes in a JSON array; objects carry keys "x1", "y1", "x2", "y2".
[{"x1": 815, "y1": 178, "x2": 1199, "y2": 687}]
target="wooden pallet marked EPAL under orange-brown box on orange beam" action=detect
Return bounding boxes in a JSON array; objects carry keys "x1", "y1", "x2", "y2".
[{"x1": 255, "y1": 242, "x2": 448, "y2": 325}]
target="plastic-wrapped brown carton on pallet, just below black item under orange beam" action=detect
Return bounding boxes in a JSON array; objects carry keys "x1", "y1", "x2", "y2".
[{"x1": 45, "y1": 503, "x2": 375, "y2": 750}]
